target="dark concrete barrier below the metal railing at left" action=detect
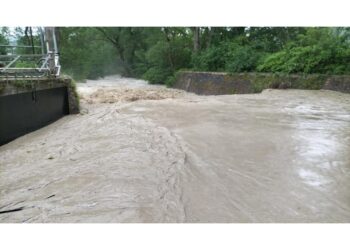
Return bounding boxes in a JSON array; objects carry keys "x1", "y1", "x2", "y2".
[{"x1": 0, "y1": 79, "x2": 79, "y2": 145}]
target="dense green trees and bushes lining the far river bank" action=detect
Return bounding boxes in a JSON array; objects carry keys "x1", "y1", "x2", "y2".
[{"x1": 0, "y1": 27, "x2": 350, "y2": 84}]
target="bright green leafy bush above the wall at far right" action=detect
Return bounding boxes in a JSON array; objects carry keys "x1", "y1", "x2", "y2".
[{"x1": 257, "y1": 30, "x2": 350, "y2": 74}]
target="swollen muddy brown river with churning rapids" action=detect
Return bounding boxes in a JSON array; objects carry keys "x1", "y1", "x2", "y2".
[{"x1": 0, "y1": 76, "x2": 350, "y2": 222}]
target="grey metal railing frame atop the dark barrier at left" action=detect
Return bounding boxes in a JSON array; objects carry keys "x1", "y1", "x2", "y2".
[{"x1": 0, "y1": 27, "x2": 61, "y2": 78}]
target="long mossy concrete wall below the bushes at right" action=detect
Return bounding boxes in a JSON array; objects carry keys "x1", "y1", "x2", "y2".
[{"x1": 173, "y1": 71, "x2": 350, "y2": 95}]
